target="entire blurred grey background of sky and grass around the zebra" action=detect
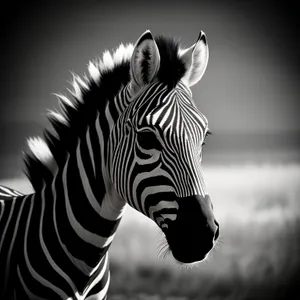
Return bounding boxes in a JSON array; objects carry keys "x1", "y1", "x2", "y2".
[{"x1": 0, "y1": 0, "x2": 300, "y2": 300}]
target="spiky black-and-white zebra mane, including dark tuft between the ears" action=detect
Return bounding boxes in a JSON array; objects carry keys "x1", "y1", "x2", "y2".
[{"x1": 23, "y1": 35, "x2": 186, "y2": 190}]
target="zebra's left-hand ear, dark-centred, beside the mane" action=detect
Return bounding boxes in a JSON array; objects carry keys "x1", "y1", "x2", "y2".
[{"x1": 130, "y1": 30, "x2": 160, "y2": 89}]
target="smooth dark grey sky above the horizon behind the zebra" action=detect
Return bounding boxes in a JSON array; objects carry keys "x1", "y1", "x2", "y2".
[{"x1": 0, "y1": 0, "x2": 300, "y2": 176}]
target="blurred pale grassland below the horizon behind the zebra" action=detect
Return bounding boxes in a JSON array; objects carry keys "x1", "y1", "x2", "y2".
[{"x1": 1, "y1": 164, "x2": 300, "y2": 300}]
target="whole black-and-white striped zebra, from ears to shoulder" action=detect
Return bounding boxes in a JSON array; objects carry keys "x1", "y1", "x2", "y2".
[{"x1": 0, "y1": 30, "x2": 219, "y2": 300}]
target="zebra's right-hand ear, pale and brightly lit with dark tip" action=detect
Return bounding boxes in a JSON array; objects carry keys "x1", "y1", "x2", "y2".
[{"x1": 180, "y1": 31, "x2": 209, "y2": 86}]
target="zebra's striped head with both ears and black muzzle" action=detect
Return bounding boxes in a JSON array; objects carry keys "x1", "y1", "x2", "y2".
[{"x1": 110, "y1": 31, "x2": 219, "y2": 263}]
